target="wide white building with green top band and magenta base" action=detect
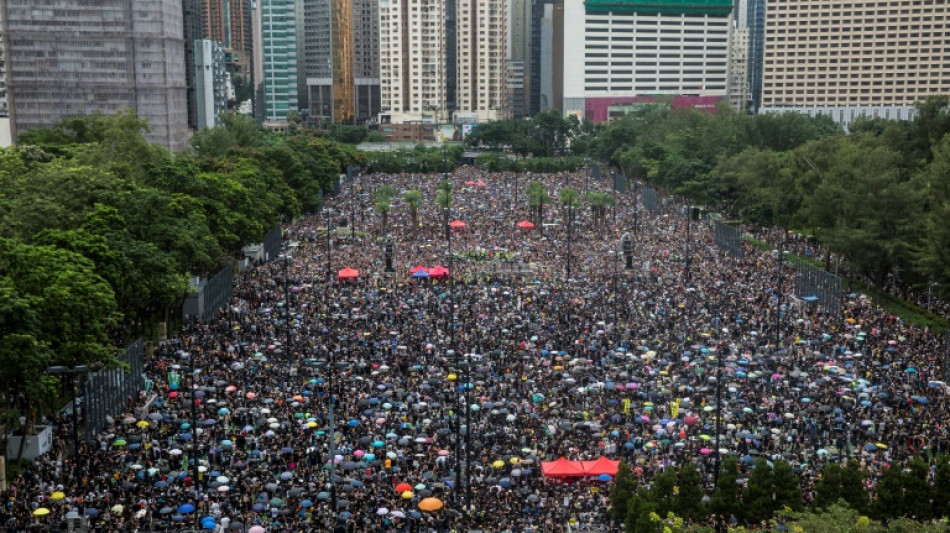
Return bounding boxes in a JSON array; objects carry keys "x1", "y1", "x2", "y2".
[{"x1": 563, "y1": 0, "x2": 732, "y2": 123}]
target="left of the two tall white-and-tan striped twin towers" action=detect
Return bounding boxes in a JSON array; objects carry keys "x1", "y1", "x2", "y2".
[{"x1": 379, "y1": 0, "x2": 450, "y2": 124}]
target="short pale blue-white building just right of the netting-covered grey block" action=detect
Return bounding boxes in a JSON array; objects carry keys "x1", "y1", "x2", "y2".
[{"x1": 193, "y1": 39, "x2": 229, "y2": 128}]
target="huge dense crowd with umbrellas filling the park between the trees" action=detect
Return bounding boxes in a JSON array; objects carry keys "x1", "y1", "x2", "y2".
[{"x1": 0, "y1": 167, "x2": 950, "y2": 533}]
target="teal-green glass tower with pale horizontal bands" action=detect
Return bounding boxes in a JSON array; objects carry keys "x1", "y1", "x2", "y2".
[{"x1": 260, "y1": 0, "x2": 298, "y2": 124}]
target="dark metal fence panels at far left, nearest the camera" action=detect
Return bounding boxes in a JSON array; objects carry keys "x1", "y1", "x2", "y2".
[{"x1": 82, "y1": 339, "x2": 145, "y2": 441}]
